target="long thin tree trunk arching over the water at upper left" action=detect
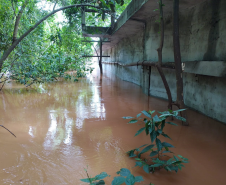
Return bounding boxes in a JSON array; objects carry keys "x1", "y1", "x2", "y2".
[{"x1": 0, "y1": 4, "x2": 100, "y2": 72}]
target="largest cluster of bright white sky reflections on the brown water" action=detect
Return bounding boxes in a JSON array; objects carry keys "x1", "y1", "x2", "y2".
[{"x1": 43, "y1": 79, "x2": 106, "y2": 149}]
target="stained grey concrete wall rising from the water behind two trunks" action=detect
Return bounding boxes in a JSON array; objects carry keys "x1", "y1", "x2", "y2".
[{"x1": 103, "y1": 0, "x2": 226, "y2": 123}]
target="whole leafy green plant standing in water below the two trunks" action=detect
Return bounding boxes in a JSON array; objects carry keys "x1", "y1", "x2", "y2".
[{"x1": 123, "y1": 109, "x2": 188, "y2": 173}]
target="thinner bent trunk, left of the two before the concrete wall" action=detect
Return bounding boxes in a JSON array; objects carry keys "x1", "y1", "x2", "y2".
[{"x1": 156, "y1": 0, "x2": 172, "y2": 110}]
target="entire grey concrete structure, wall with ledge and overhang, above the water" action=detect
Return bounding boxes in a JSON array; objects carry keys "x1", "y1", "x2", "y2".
[{"x1": 83, "y1": 0, "x2": 226, "y2": 123}]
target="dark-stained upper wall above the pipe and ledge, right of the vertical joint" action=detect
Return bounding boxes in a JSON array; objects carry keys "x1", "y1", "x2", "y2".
[{"x1": 145, "y1": 0, "x2": 226, "y2": 62}]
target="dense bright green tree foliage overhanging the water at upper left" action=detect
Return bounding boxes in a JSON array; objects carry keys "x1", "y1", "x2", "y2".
[{"x1": 0, "y1": 0, "x2": 130, "y2": 89}]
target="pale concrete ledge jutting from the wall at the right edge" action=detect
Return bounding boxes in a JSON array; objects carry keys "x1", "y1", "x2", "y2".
[{"x1": 184, "y1": 61, "x2": 226, "y2": 77}]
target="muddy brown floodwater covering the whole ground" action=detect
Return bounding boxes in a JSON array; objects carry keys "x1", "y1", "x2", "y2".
[{"x1": 0, "y1": 70, "x2": 226, "y2": 185}]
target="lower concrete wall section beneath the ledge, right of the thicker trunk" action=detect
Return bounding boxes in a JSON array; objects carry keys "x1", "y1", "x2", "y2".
[{"x1": 184, "y1": 73, "x2": 226, "y2": 123}]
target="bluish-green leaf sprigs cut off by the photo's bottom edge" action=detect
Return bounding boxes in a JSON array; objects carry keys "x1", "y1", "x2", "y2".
[{"x1": 80, "y1": 168, "x2": 144, "y2": 185}]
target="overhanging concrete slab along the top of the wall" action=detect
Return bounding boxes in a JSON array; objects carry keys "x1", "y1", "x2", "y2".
[{"x1": 83, "y1": 0, "x2": 208, "y2": 49}]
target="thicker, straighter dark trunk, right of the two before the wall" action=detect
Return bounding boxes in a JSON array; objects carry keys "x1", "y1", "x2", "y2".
[{"x1": 173, "y1": 0, "x2": 188, "y2": 125}]
